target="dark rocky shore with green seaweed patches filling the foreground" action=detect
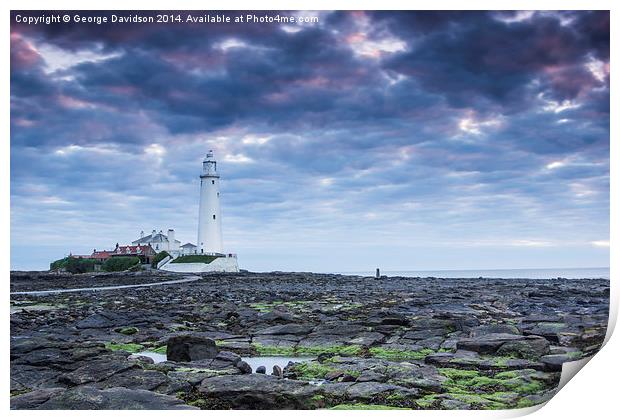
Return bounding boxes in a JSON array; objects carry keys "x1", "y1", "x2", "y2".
[{"x1": 11, "y1": 272, "x2": 609, "y2": 409}]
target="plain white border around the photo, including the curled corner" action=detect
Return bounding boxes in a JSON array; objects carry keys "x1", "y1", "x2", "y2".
[{"x1": 0, "y1": 0, "x2": 620, "y2": 420}]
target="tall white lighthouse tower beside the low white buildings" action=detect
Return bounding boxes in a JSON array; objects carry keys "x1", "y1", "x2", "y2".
[{"x1": 197, "y1": 150, "x2": 224, "y2": 255}]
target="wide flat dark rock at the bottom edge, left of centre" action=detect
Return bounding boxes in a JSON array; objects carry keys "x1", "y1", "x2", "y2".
[{"x1": 34, "y1": 386, "x2": 195, "y2": 410}]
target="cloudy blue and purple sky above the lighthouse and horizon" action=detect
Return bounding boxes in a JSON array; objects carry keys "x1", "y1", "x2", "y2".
[{"x1": 10, "y1": 11, "x2": 610, "y2": 272}]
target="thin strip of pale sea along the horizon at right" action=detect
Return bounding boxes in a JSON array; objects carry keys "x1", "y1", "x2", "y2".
[{"x1": 339, "y1": 267, "x2": 609, "y2": 279}]
